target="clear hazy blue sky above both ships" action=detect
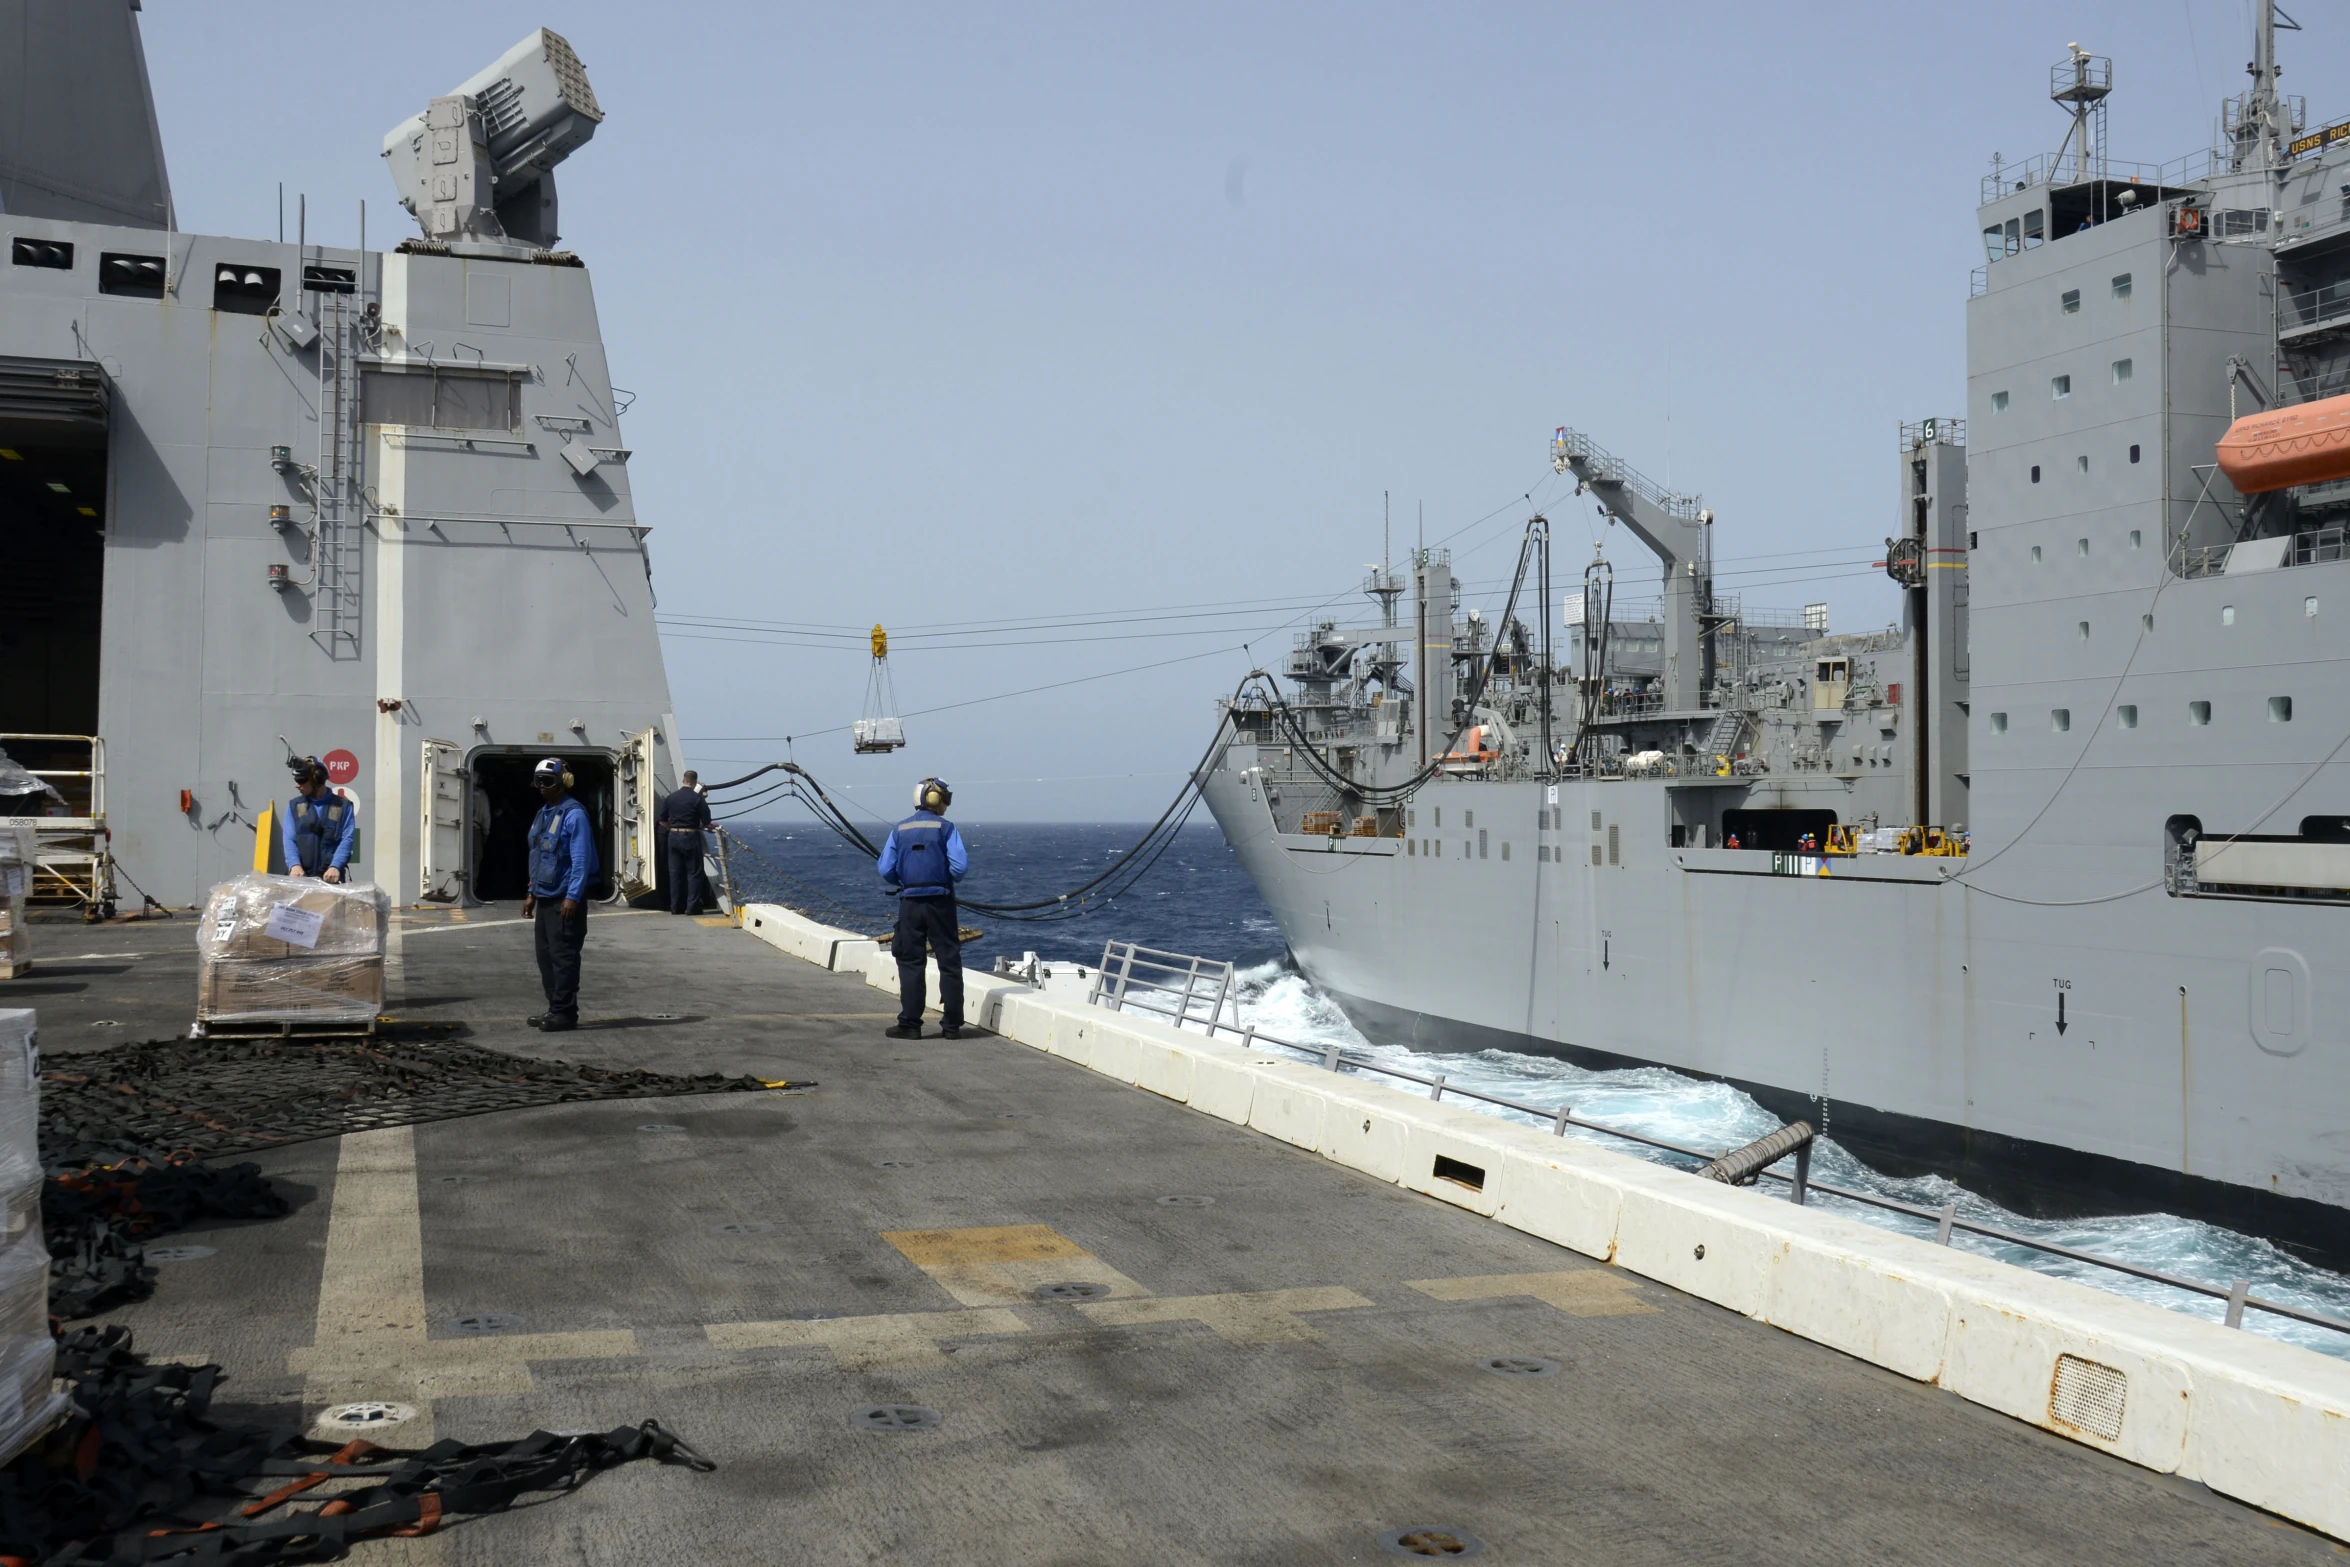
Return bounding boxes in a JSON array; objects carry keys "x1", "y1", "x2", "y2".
[{"x1": 146, "y1": 0, "x2": 2350, "y2": 820}]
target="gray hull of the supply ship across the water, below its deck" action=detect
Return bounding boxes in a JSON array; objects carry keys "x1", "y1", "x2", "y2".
[{"x1": 1208, "y1": 765, "x2": 2350, "y2": 1264}]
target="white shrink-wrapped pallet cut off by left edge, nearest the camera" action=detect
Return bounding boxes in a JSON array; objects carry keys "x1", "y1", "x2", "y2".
[{"x1": 0, "y1": 1010, "x2": 66, "y2": 1464}]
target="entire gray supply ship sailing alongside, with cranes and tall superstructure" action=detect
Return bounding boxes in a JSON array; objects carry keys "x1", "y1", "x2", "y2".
[{"x1": 1206, "y1": 7, "x2": 2350, "y2": 1259}]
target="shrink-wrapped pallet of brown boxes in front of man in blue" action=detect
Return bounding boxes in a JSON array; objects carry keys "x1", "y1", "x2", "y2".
[{"x1": 195, "y1": 874, "x2": 392, "y2": 1024}]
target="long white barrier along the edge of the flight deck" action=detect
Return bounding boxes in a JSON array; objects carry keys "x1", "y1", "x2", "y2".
[{"x1": 745, "y1": 904, "x2": 2350, "y2": 1539}]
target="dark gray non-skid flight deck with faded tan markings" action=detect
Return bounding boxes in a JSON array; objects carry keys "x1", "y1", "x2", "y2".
[{"x1": 7, "y1": 907, "x2": 2341, "y2": 1567}]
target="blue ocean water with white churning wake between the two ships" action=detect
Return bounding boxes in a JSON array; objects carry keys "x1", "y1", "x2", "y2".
[{"x1": 736, "y1": 822, "x2": 2350, "y2": 1358}]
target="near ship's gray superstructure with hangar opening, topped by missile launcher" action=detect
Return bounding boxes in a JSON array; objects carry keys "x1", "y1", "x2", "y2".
[{"x1": 0, "y1": 12, "x2": 674, "y2": 914}]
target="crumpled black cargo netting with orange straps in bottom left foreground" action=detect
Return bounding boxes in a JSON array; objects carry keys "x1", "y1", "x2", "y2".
[{"x1": 0, "y1": 1327, "x2": 717, "y2": 1567}]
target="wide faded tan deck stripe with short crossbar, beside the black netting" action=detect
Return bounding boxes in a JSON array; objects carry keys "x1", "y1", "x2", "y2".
[{"x1": 287, "y1": 1125, "x2": 637, "y2": 1418}]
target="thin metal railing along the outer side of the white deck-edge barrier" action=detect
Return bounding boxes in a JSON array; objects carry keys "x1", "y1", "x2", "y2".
[{"x1": 1088, "y1": 963, "x2": 2350, "y2": 1334}]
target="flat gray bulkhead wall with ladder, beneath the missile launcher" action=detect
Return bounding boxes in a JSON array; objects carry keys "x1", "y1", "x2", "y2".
[{"x1": 0, "y1": 218, "x2": 674, "y2": 904}]
